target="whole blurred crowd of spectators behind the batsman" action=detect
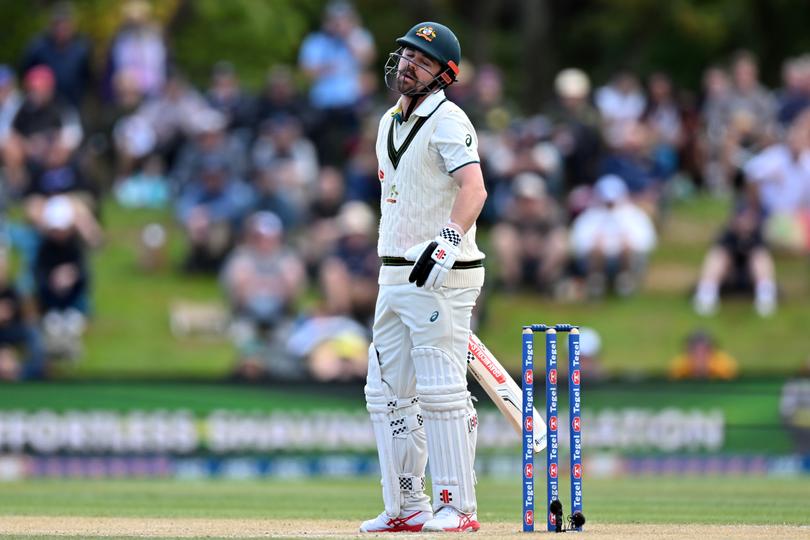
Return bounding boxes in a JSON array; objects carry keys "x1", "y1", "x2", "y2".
[{"x1": 0, "y1": 0, "x2": 810, "y2": 380}]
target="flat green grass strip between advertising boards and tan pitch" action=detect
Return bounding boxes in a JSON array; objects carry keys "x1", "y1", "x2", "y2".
[{"x1": 0, "y1": 475, "x2": 810, "y2": 531}]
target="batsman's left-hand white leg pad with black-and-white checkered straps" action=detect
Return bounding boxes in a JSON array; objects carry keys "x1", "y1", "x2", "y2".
[{"x1": 365, "y1": 343, "x2": 430, "y2": 517}]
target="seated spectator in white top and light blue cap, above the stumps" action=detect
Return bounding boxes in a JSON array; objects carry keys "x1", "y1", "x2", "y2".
[{"x1": 570, "y1": 175, "x2": 656, "y2": 297}]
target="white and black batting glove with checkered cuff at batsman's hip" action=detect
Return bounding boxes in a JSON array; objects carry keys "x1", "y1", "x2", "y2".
[{"x1": 405, "y1": 227, "x2": 461, "y2": 290}]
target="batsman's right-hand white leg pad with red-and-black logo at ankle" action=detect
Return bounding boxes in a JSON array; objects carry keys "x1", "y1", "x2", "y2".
[{"x1": 411, "y1": 347, "x2": 478, "y2": 513}]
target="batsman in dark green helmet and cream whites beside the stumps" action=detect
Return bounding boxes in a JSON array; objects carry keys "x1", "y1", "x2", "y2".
[{"x1": 360, "y1": 22, "x2": 487, "y2": 532}]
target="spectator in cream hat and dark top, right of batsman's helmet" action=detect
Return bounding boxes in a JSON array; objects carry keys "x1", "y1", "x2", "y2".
[{"x1": 549, "y1": 68, "x2": 603, "y2": 192}]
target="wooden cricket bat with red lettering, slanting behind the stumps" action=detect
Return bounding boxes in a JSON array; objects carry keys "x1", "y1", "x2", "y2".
[{"x1": 467, "y1": 333, "x2": 546, "y2": 453}]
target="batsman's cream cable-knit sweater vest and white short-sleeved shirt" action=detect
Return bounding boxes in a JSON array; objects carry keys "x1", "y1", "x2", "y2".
[{"x1": 377, "y1": 90, "x2": 484, "y2": 288}]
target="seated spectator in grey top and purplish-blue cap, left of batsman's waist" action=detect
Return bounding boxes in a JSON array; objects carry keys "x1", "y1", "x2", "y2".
[{"x1": 220, "y1": 211, "x2": 306, "y2": 371}]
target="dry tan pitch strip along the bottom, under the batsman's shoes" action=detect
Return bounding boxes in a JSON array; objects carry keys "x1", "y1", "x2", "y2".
[{"x1": 0, "y1": 516, "x2": 810, "y2": 540}]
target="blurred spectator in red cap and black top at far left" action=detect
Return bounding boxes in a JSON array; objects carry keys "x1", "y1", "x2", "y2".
[{"x1": 3, "y1": 65, "x2": 83, "y2": 190}]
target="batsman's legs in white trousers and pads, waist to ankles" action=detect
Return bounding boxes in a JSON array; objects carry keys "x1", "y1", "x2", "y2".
[{"x1": 366, "y1": 283, "x2": 480, "y2": 516}]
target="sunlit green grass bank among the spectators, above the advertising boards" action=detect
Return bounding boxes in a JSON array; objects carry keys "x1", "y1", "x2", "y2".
[{"x1": 36, "y1": 197, "x2": 810, "y2": 380}]
